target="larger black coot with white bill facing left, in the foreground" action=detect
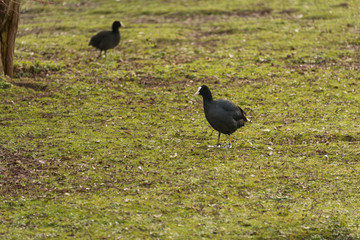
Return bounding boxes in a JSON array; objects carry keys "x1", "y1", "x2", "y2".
[{"x1": 195, "y1": 85, "x2": 249, "y2": 148}]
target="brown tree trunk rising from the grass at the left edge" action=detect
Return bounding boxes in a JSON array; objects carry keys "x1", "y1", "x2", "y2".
[{"x1": 0, "y1": 0, "x2": 20, "y2": 77}]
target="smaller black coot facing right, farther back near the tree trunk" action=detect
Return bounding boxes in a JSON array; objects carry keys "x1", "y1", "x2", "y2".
[{"x1": 89, "y1": 21, "x2": 124, "y2": 57}]
